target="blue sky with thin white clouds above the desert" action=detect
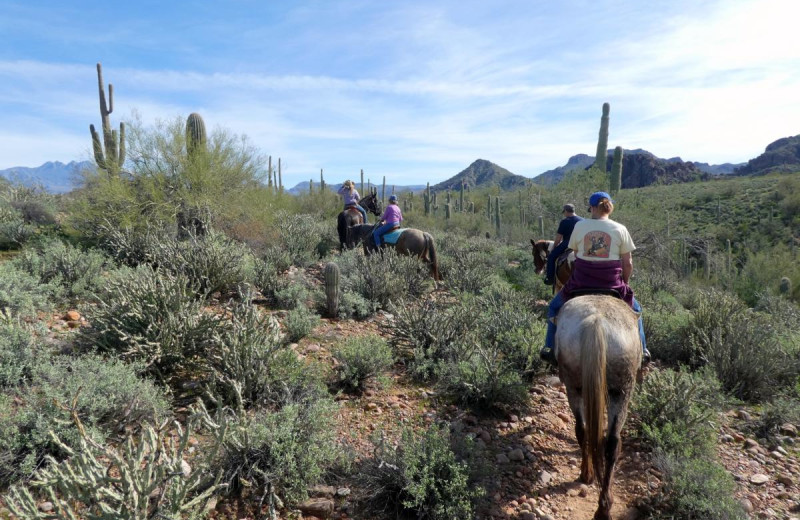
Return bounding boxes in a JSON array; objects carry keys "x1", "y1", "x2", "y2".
[{"x1": 0, "y1": 0, "x2": 800, "y2": 186}]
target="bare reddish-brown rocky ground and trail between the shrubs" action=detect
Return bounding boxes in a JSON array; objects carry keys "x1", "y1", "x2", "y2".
[{"x1": 6, "y1": 304, "x2": 800, "y2": 520}]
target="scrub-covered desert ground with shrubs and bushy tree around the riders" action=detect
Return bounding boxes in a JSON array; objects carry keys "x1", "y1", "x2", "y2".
[{"x1": 0, "y1": 95, "x2": 800, "y2": 519}]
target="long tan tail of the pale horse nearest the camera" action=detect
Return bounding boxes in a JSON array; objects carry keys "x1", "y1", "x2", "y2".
[{"x1": 581, "y1": 315, "x2": 608, "y2": 486}]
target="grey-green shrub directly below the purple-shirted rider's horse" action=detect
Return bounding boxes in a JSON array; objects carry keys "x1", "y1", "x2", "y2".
[{"x1": 339, "y1": 249, "x2": 431, "y2": 308}]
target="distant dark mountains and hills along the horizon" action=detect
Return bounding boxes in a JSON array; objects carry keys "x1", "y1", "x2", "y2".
[{"x1": 0, "y1": 135, "x2": 800, "y2": 195}]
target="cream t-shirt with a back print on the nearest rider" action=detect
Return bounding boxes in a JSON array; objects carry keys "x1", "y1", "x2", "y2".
[{"x1": 569, "y1": 219, "x2": 636, "y2": 262}]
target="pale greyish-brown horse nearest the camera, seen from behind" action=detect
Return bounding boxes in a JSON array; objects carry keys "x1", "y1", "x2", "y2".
[{"x1": 556, "y1": 295, "x2": 642, "y2": 520}]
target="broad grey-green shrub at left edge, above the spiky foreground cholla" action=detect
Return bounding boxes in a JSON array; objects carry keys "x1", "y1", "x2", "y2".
[{"x1": 0, "y1": 356, "x2": 169, "y2": 484}]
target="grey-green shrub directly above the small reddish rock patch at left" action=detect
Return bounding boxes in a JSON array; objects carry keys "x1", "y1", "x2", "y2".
[{"x1": 13, "y1": 239, "x2": 109, "y2": 300}]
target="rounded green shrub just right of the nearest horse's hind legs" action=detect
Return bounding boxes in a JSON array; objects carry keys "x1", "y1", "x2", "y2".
[{"x1": 631, "y1": 369, "x2": 722, "y2": 457}]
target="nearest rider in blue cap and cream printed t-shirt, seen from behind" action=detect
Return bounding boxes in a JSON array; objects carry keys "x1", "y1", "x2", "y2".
[{"x1": 539, "y1": 191, "x2": 650, "y2": 365}]
